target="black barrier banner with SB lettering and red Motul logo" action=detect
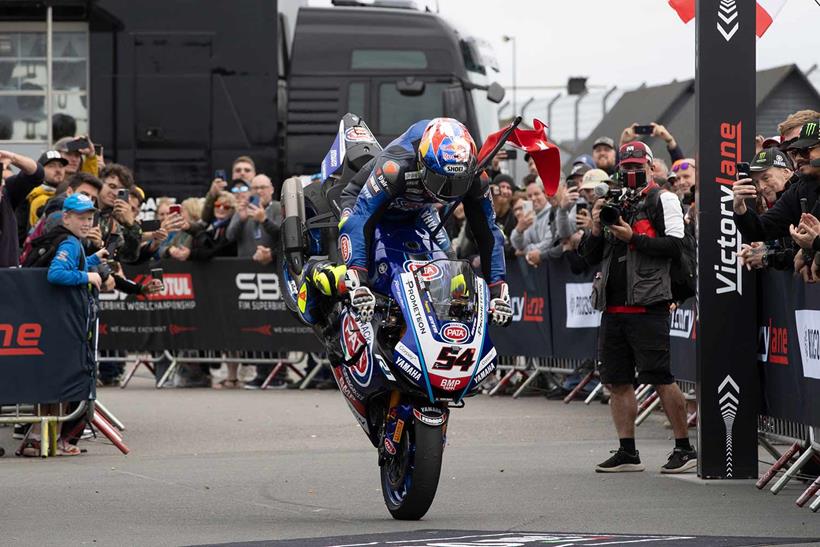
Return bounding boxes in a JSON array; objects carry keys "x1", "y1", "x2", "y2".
[{"x1": 99, "y1": 258, "x2": 321, "y2": 351}]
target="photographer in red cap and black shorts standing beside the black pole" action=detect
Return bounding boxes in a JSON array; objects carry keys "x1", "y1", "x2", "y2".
[{"x1": 579, "y1": 142, "x2": 697, "y2": 473}]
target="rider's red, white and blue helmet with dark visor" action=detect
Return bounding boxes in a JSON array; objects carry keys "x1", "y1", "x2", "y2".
[{"x1": 419, "y1": 118, "x2": 476, "y2": 201}]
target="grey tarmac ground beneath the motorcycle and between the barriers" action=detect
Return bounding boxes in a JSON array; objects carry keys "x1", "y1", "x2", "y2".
[{"x1": 0, "y1": 377, "x2": 820, "y2": 546}]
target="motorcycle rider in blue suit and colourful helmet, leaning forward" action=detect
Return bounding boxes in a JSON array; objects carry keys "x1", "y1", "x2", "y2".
[{"x1": 300, "y1": 118, "x2": 512, "y2": 325}]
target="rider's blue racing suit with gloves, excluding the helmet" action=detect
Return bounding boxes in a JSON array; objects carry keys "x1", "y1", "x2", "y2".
[{"x1": 339, "y1": 120, "x2": 512, "y2": 324}]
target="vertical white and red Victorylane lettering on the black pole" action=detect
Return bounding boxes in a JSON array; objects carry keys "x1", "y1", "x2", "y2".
[{"x1": 715, "y1": 122, "x2": 743, "y2": 295}]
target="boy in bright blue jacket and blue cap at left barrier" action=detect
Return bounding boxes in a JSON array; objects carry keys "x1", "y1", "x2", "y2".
[{"x1": 48, "y1": 194, "x2": 108, "y2": 290}]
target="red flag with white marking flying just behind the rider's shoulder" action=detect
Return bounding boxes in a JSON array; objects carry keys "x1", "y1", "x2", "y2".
[{"x1": 478, "y1": 119, "x2": 561, "y2": 196}]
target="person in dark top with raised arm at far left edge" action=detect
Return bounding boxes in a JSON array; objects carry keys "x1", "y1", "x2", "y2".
[{"x1": 0, "y1": 150, "x2": 44, "y2": 268}]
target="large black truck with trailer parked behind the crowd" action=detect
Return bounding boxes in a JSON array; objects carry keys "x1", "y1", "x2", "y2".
[{"x1": 0, "y1": 0, "x2": 504, "y2": 197}]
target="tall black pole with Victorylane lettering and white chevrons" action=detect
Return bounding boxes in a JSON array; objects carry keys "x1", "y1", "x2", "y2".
[{"x1": 695, "y1": 0, "x2": 759, "y2": 479}]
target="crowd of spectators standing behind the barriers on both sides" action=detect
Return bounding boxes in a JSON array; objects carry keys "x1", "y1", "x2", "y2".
[{"x1": 0, "y1": 110, "x2": 820, "y2": 460}]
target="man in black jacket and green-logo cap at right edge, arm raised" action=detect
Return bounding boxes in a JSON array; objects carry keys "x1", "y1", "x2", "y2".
[{"x1": 733, "y1": 120, "x2": 820, "y2": 281}]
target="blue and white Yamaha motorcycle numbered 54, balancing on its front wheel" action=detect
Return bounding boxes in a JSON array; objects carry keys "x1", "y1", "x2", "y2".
[{"x1": 282, "y1": 114, "x2": 496, "y2": 520}]
